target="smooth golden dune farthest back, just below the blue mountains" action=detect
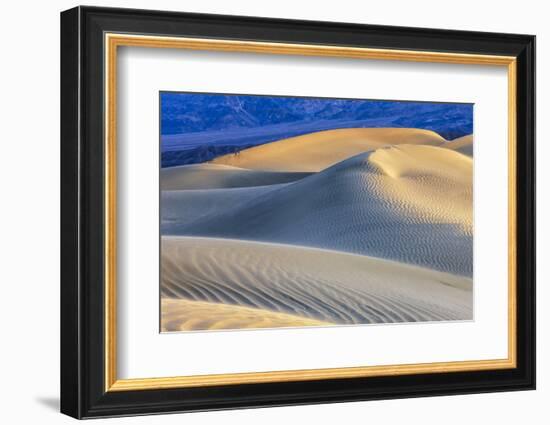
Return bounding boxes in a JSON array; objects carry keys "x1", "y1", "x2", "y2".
[{"x1": 212, "y1": 128, "x2": 445, "y2": 171}]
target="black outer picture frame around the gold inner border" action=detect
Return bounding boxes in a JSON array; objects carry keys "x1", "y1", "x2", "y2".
[{"x1": 61, "y1": 7, "x2": 535, "y2": 418}]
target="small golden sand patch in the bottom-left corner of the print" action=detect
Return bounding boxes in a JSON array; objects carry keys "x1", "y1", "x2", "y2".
[{"x1": 161, "y1": 298, "x2": 333, "y2": 332}]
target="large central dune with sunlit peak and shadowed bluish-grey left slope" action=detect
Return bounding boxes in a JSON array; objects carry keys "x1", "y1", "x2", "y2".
[{"x1": 167, "y1": 145, "x2": 472, "y2": 276}]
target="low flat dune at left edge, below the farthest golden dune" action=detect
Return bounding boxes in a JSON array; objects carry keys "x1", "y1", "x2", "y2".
[{"x1": 160, "y1": 164, "x2": 311, "y2": 190}]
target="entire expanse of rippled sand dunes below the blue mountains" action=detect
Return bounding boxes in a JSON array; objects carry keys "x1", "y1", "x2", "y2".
[{"x1": 161, "y1": 129, "x2": 473, "y2": 331}]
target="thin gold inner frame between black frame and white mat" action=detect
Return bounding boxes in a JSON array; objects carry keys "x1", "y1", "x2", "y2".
[{"x1": 104, "y1": 33, "x2": 517, "y2": 391}]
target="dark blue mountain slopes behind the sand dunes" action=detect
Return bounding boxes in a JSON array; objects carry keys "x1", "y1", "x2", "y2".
[{"x1": 160, "y1": 92, "x2": 473, "y2": 167}]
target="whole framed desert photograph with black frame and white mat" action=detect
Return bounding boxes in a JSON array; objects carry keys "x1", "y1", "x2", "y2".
[{"x1": 61, "y1": 7, "x2": 535, "y2": 418}]
